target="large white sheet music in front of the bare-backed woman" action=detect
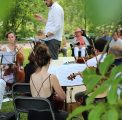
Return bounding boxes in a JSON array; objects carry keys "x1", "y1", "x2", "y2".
[{"x1": 48, "y1": 63, "x2": 86, "y2": 86}]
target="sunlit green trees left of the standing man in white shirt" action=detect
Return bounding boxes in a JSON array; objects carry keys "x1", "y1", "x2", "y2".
[{"x1": 0, "y1": 0, "x2": 47, "y2": 39}]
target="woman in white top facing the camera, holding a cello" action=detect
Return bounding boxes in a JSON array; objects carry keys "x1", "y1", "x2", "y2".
[{"x1": 2, "y1": 32, "x2": 24, "y2": 86}]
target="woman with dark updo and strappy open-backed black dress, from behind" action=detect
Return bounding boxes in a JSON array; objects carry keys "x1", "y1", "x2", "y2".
[{"x1": 30, "y1": 44, "x2": 67, "y2": 120}]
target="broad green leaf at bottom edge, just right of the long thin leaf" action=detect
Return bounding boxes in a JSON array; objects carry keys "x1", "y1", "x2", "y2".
[{"x1": 88, "y1": 103, "x2": 106, "y2": 120}]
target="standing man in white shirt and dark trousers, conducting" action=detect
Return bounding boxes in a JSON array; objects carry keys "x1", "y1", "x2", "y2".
[{"x1": 35, "y1": 0, "x2": 64, "y2": 60}]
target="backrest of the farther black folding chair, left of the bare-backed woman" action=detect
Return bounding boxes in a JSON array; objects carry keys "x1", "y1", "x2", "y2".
[{"x1": 12, "y1": 83, "x2": 31, "y2": 99}]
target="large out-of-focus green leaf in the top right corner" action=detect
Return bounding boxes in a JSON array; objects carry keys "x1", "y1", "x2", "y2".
[{"x1": 86, "y1": 0, "x2": 122, "y2": 25}]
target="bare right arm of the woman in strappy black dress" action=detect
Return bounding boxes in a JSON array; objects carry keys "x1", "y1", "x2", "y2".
[{"x1": 51, "y1": 75, "x2": 66, "y2": 100}]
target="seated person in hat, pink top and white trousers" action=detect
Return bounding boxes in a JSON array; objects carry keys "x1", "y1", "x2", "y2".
[{"x1": 74, "y1": 28, "x2": 90, "y2": 60}]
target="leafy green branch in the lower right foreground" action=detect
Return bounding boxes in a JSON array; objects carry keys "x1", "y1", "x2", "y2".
[{"x1": 68, "y1": 55, "x2": 122, "y2": 120}]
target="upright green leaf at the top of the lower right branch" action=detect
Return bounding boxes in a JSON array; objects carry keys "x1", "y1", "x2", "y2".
[{"x1": 99, "y1": 55, "x2": 114, "y2": 75}]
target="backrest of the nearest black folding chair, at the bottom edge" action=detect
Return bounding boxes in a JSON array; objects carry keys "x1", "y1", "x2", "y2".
[{"x1": 14, "y1": 96, "x2": 55, "y2": 120}]
